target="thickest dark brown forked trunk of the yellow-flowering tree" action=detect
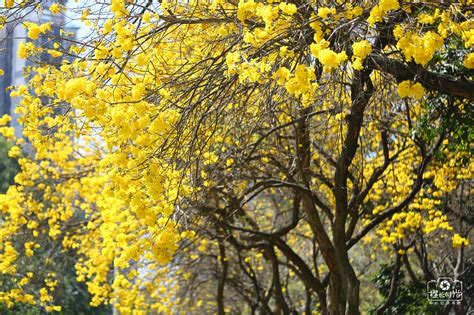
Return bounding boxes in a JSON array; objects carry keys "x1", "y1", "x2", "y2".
[{"x1": 297, "y1": 66, "x2": 373, "y2": 315}]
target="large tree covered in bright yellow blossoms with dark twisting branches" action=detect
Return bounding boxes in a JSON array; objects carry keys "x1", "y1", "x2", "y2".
[{"x1": 0, "y1": 0, "x2": 474, "y2": 314}]
